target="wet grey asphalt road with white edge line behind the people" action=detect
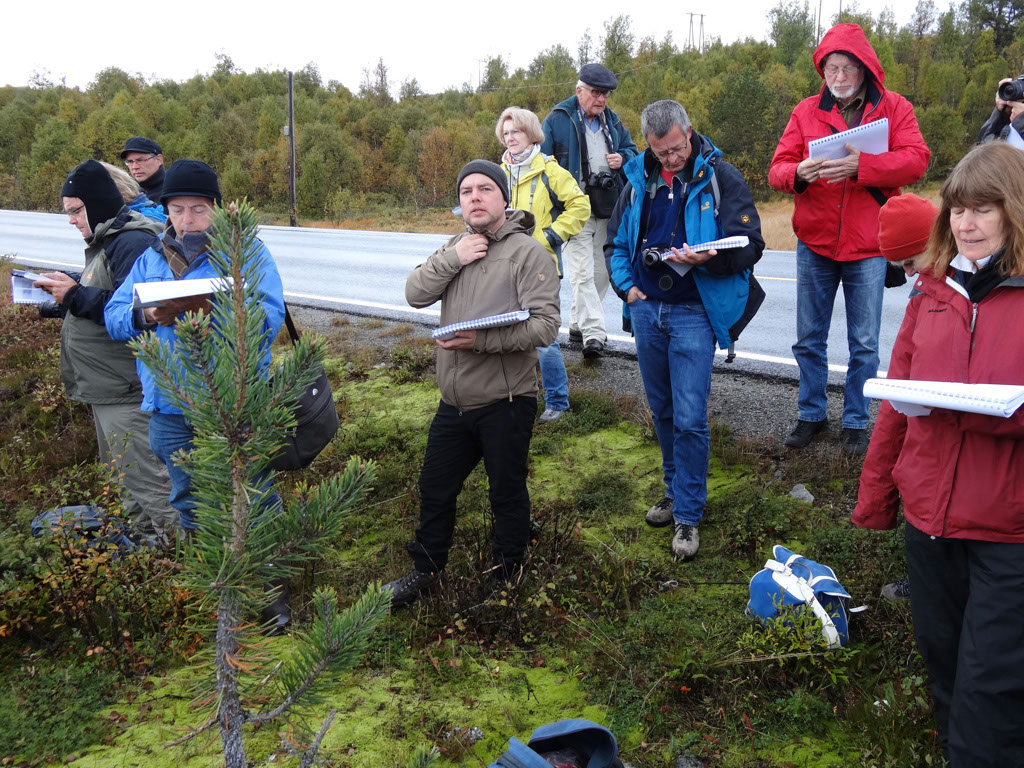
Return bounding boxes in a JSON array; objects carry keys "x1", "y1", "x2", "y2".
[{"x1": 0, "y1": 210, "x2": 910, "y2": 383}]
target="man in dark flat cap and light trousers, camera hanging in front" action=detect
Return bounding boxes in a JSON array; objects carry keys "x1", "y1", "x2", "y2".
[{"x1": 541, "y1": 63, "x2": 637, "y2": 357}]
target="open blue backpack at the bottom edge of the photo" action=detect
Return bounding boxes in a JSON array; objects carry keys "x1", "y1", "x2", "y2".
[{"x1": 488, "y1": 720, "x2": 623, "y2": 768}]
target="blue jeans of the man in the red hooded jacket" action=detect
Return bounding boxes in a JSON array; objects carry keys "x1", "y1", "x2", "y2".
[{"x1": 793, "y1": 241, "x2": 886, "y2": 429}]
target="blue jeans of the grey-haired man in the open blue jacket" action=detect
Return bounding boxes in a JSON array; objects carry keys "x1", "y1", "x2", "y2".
[{"x1": 629, "y1": 299, "x2": 715, "y2": 525}]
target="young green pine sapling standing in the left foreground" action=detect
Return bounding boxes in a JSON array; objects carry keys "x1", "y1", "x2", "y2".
[{"x1": 134, "y1": 202, "x2": 391, "y2": 768}]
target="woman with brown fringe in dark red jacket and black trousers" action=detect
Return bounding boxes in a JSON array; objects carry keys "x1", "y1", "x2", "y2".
[{"x1": 853, "y1": 142, "x2": 1024, "y2": 768}]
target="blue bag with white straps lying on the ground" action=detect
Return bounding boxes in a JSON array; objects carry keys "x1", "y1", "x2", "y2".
[{"x1": 746, "y1": 544, "x2": 850, "y2": 648}]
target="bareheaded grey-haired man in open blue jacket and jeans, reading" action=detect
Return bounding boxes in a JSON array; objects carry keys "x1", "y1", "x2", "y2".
[{"x1": 604, "y1": 100, "x2": 765, "y2": 560}]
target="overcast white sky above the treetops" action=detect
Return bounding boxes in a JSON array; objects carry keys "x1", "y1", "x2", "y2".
[{"x1": 6, "y1": 0, "x2": 948, "y2": 93}]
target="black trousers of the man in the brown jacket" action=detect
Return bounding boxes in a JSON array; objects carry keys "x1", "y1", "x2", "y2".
[{"x1": 408, "y1": 396, "x2": 537, "y2": 572}]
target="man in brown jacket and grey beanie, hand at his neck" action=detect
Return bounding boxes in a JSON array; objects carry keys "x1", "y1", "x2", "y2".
[{"x1": 385, "y1": 160, "x2": 560, "y2": 606}]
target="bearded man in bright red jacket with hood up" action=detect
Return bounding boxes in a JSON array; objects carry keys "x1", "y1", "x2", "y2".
[{"x1": 768, "y1": 24, "x2": 931, "y2": 454}]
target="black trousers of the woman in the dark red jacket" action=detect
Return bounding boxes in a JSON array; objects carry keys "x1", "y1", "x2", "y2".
[{"x1": 906, "y1": 523, "x2": 1024, "y2": 768}]
